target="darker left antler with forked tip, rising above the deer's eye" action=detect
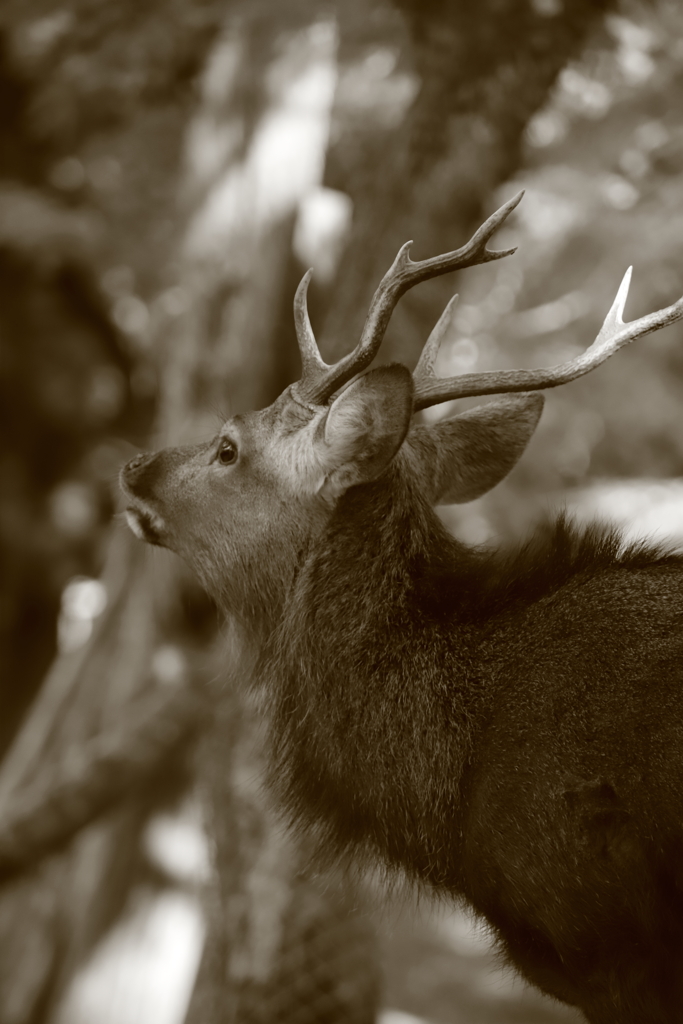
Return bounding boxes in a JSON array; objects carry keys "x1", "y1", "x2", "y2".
[{"x1": 294, "y1": 191, "x2": 524, "y2": 404}]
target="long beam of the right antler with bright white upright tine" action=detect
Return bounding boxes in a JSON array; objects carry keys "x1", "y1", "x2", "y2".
[{"x1": 415, "y1": 267, "x2": 683, "y2": 412}]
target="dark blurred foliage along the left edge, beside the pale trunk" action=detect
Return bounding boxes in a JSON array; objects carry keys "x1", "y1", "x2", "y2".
[{"x1": 0, "y1": 2, "x2": 229, "y2": 748}]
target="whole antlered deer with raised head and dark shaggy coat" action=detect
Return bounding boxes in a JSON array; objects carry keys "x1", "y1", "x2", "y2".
[{"x1": 121, "y1": 193, "x2": 683, "y2": 1024}]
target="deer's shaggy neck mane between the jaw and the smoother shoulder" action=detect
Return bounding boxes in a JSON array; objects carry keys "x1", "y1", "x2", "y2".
[{"x1": 268, "y1": 466, "x2": 485, "y2": 886}]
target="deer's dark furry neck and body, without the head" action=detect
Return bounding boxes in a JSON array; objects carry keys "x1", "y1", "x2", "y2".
[{"x1": 263, "y1": 459, "x2": 683, "y2": 1024}]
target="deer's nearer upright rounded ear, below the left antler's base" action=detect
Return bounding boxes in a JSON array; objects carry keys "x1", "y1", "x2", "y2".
[{"x1": 315, "y1": 364, "x2": 413, "y2": 498}]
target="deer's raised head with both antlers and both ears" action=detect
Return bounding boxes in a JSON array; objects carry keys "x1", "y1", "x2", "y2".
[{"x1": 121, "y1": 193, "x2": 683, "y2": 623}]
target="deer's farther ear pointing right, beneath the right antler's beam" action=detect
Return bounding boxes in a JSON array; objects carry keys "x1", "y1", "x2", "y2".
[{"x1": 407, "y1": 392, "x2": 544, "y2": 505}]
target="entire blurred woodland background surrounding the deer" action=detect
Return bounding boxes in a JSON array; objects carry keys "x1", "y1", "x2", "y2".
[{"x1": 0, "y1": 0, "x2": 683, "y2": 1024}]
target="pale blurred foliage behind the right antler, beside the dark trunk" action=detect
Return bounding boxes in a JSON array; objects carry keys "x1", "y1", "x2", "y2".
[{"x1": 441, "y1": 4, "x2": 683, "y2": 541}]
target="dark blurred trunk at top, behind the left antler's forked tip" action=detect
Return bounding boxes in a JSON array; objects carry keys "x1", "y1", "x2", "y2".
[{"x1": 322, "y1": 0, "x2": 613, "y2": 360}]
